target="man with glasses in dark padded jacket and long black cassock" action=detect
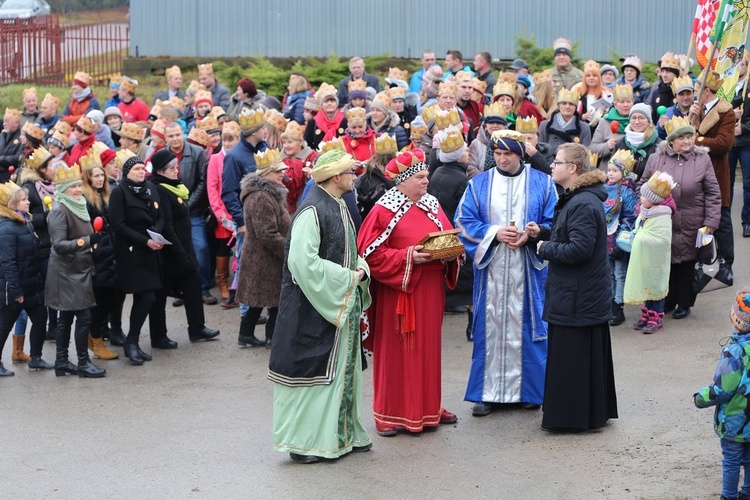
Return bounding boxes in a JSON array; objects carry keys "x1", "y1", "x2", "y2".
[{"x1": 527, "y1": 143, "x2": 617, "y2": 432}]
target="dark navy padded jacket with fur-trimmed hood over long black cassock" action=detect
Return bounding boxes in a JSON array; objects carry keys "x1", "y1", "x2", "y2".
[{"x1": 539, "y1": 170, "x2": 612, "y2": 327}]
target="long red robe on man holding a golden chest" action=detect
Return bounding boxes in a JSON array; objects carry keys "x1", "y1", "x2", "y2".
[{"x1": 357, "y1": 188, "x2": 459, "y2": 432}]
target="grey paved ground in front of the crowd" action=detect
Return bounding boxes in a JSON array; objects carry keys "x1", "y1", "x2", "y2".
[{"x1": 0, "y1": 190, "x2": 750, "y2": 499}]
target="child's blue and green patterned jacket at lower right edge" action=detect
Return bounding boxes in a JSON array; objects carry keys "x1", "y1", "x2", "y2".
[{"x1": 693, "y1": 331, "x2": 750, "y2": 443}]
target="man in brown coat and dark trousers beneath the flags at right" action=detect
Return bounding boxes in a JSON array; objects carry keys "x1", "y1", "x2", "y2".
[{"x1": 690, "y1": 71, "x2": 734, "y2": 286}]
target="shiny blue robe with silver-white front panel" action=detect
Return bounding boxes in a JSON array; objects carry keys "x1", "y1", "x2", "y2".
[{"x1": 455, "y1": 165, "x2": 557, "y2": 404}]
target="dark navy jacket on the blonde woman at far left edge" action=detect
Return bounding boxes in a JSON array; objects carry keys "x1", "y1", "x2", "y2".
[{"x1": 0, "y1": 206, "x2": 44, "y2": 308}]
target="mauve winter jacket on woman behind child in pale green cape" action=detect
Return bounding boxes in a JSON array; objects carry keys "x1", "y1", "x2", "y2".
[{"x1": 638, "y1": 141, "x2": 721, "y2": 264}]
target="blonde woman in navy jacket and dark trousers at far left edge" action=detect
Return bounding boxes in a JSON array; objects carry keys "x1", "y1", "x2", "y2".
[{"x1": 0, "y1": 182, "x2": 52, "y2": 377}]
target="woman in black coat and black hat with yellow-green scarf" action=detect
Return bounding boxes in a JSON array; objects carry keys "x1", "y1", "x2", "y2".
[{"x1": 148, "y1": 149, "x2": 219, "y2": 349}]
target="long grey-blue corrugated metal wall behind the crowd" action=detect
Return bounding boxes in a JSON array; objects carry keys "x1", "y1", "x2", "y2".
[{"x1": 130, "y1": 0, "x2": 696, "y2": 62}]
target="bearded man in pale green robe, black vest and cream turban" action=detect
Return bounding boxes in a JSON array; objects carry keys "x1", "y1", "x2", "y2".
[{"x1": 268, "y1": 150, "x2": 372, "y2": 464}]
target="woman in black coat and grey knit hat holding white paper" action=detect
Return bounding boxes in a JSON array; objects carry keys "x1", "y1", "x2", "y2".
[{"x1": 109, "y1": 150, "x2": 165, "y2": 365}]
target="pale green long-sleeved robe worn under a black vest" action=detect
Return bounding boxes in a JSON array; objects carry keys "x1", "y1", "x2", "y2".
[{"x1": 273, "y1": 199, "x2": 371, "y2": 458}]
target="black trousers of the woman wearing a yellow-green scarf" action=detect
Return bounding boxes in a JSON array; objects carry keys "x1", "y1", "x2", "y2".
[{"x1": 148, "y1": 270, "x2": 206, "y2": 341}]
